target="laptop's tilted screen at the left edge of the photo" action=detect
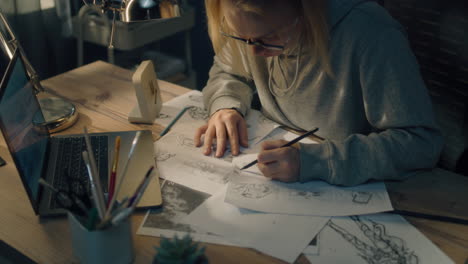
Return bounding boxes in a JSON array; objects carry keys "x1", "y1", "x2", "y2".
[{"x1": 0, "y1": 51, "x2": 49, "y2": 202}]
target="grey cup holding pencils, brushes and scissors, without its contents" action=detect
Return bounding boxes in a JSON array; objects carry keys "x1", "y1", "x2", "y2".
[{"x1": 68, "y1": 213, "x2": 134, "y2": 264}]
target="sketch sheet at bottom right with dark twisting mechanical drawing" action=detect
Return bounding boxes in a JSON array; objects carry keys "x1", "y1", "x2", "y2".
[{"x1": 305, "y1": 214, "x2": 453, "y2": 264}]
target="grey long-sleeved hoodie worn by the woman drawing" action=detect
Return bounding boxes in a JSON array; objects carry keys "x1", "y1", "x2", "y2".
[{"x1": 203, "y1": 0, "x2": 442, "y2": 185}]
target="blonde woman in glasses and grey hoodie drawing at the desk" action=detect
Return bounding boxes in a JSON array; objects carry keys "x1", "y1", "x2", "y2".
[{"x1": 195, "y1": 0, "x2": 442, "y2": 185}]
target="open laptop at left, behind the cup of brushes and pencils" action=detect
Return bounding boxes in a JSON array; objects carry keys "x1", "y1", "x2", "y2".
[{"x1": 0, "y1": 50, "x2": 162, "y2": 216}]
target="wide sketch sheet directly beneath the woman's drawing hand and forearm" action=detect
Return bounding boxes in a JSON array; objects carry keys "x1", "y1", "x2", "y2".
[{"x1": 225, "y1": 171, "x2": 393, "y2": 216}]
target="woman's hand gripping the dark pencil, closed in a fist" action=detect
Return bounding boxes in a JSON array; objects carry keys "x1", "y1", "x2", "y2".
[{"x1": 257, "y1": 140, "x2": 301, "y2": 182}]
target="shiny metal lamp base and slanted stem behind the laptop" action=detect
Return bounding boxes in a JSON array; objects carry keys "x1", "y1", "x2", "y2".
[{"x1": 0, "y1": 10, "x2": 78, "y2": 133}]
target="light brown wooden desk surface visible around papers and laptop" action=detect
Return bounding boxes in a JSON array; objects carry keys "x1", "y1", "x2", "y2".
[{"x1": 0, "y1": 61, "x2": 468, "y2": 263}]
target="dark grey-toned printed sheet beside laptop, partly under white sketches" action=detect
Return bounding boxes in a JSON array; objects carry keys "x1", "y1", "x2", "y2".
[{"x1": 137, "y1": 181, "x2": 238, "y2": 246}]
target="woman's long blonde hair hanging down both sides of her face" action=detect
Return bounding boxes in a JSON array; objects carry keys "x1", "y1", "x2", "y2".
[{"x1": 205, "y1": 0, "x2": 333, "y2": 77}]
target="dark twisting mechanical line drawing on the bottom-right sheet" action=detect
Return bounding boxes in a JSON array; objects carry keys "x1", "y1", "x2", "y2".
[{"x1": 327, "y1": 216, "x2": 419, "y2": 264}]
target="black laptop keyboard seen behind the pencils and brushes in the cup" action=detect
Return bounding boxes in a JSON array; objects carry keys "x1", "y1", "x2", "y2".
[{"x1": 51, "y1": 136, "x2": 108, "y2": 209}]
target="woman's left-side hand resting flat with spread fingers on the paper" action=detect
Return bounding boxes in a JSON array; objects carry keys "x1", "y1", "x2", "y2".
[{"x1": 194, "y1": 109, "x2": 248, "y2": 158}]
